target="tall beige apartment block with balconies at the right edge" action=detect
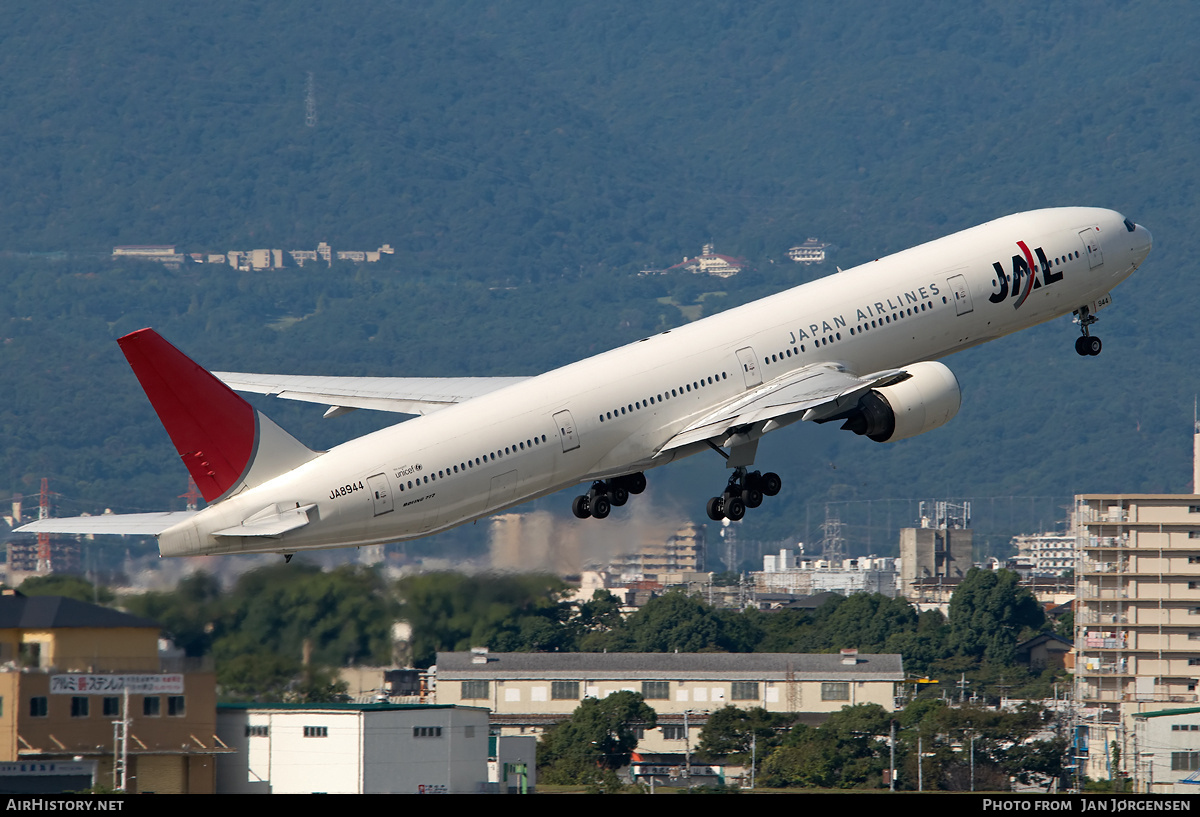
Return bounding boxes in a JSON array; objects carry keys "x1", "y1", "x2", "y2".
[{"x1": 1075, "y1": 494, "x2": 1200, "y2": 779}]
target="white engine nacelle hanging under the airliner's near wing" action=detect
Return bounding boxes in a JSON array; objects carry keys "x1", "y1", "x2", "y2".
[{"x1": 841, "y1": 360, "x2": 962, "y2": 443}]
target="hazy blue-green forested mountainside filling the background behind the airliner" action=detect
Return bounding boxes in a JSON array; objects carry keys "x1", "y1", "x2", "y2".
[{"x1": 0, "y1": 0, "x2": 1200, "y2": 563}]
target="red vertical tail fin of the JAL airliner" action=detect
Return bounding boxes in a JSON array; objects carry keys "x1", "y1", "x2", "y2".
[{"x1": 118, "y1": 329, "x2": 317, "y2": 503}]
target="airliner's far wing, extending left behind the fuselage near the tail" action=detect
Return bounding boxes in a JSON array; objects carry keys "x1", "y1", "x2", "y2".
[{"x1": 212, "y1": 372, "x2": 528, "y2": 416}]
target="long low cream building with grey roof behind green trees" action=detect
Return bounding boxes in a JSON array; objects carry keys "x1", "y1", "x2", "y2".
[{"x1": 437, "y1": 649, "x2": 904, "y2": 752}]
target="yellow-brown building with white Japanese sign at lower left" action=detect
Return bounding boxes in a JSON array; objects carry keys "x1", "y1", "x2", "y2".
[{"x1": 0, "y1": 591, "x2": 220, "y2": 794}]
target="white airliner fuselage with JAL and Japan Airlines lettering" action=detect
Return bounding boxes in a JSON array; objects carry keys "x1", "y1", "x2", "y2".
[{"x1": 158, "y1": 208, "x2": 1150, "y2": 555}]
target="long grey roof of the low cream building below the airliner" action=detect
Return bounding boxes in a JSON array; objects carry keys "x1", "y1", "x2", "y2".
[{"x1": 437, "y1": 653, "x2": 904, "y2": 681}]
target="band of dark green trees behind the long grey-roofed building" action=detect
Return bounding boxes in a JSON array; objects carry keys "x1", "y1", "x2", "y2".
[{"x1": 22, "y1": 561, "x2": 1061, "y2": 699}]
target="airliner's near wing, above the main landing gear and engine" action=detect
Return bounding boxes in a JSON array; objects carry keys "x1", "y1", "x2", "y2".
[{"x1": 659, "y1": 364, "x2": 910, "y2": 452}]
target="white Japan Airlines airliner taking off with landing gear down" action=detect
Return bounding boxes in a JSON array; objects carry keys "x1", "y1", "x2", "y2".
[{"x1": 18, "y1": 208, "x2": 1152, "y2": 558}]
